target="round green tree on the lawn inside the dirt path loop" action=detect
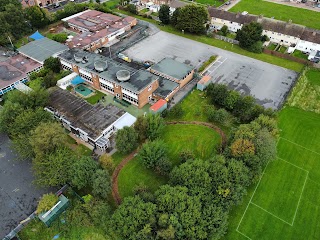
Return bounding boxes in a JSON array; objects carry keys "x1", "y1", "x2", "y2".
[{"x1": 138, "y1": 140, "x2": 171, "y2": 174}]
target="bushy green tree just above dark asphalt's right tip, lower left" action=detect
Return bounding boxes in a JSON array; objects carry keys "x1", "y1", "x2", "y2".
[{"x1": 32, "y1": 147, "x2": 77, "y2": 187}]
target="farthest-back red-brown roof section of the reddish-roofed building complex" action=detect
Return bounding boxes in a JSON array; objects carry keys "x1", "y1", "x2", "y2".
[{"x1": 62, "y1": 10, "x2": 135, "y2": 32}]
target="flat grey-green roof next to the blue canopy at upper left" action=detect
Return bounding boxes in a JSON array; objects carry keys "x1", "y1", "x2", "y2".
[{"x1": 18, "y1": 38, "x2": 68, "y2": 63}]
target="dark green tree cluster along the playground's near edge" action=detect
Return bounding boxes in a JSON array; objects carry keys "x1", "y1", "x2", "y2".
[{"x1": 206, "y1": 83, "x2": 274, "y2": 123}]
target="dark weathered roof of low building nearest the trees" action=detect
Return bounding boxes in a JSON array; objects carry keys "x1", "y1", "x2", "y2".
[{"x1": 49, "y1": 88, "x2": 126, "y2": 140}]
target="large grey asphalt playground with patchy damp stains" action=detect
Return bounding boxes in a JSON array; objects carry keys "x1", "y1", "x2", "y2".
[{"x1": 123, "y1": 31, "x2": 298, "y2": 109}]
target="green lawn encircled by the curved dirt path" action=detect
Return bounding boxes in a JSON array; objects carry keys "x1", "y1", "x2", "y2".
[{"x1": 118, "y1": 125, "x2": 221, "y2": 198}]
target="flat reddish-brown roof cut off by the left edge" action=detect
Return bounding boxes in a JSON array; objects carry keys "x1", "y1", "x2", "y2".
[{"x1": 0, "y1": 61, "x2": 27, "y2": 88}]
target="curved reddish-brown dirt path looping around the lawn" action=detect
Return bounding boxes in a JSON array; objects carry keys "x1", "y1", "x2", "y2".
[{"x1": 112, "y1": 121, "x2": 227, "y2": 205}]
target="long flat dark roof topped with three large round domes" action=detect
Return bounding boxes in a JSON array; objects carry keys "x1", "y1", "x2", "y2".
[{"x1": 59, "y1": 48, "x2": 158, "y2": 93}]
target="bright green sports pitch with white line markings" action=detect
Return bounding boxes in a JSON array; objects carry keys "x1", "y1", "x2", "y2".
[{"x1": 225, "y1": 107, "x2": 320, "y2": 240}]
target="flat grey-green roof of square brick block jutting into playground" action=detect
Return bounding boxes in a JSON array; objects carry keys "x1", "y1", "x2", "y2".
[{"x1": 151, "y1": 58, "x2": 193, "y2": 79}]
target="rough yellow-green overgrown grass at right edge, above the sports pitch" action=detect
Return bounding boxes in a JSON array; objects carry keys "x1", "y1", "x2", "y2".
[{"x1": 288, "y1": 68, "x2": 320, "y2": 113}]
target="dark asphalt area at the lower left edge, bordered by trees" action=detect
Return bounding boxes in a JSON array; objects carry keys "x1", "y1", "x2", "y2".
[{"x1": 0, "y1": 134, "x2": 48, "y2": 239}]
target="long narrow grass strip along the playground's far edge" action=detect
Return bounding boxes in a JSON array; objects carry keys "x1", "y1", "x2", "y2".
[{"x1": 115, "y1": 10, "x2": 304, "y2": 72}]
